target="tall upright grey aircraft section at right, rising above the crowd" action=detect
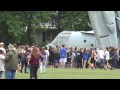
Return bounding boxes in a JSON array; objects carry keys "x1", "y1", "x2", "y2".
[{"x1": 88, "y1": 11, "x2": 120, "y2": 48}]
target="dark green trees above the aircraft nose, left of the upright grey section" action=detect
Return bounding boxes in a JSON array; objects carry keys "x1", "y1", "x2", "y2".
[{"x1": 50, "y1": 11, "x2": 90, "y2": 32}]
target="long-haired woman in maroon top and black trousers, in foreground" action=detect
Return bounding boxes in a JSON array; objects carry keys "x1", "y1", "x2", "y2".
[{"x1": 29, "y1": 47, "x2": 40, "y2": 79}]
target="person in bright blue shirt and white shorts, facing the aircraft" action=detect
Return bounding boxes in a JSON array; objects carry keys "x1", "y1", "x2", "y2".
[{"x1": 60, "y1": 45, "x2": 67, "y2": 68}]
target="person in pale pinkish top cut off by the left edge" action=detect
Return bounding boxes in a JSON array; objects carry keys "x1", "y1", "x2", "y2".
[{"x1": 0, "y1": 50, "x2": 5, "y2": 79}]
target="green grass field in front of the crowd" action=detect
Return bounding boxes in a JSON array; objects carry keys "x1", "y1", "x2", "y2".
[{"x1": 16, "y1": 68, "x2": 120, "y2": 79}]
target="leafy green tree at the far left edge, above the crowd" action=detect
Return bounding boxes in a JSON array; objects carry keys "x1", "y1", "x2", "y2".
[{"x1": 0, "y1": 11, "x2": 22, "y2": 44}]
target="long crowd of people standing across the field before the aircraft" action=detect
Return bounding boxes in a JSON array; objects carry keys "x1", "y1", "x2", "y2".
[{"x1": 0, "y1": 43, "x2": 120, "y2": 79}]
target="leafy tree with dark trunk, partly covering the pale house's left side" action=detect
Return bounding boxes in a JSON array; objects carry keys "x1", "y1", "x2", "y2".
[{"x1": 19, "y1": 11, "x2": 51, "y2": 44}]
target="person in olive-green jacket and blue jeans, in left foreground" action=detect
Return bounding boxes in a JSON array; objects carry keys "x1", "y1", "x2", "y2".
[{"x1": 4, "y1": 44, "x2": 18, "y2": 79}]
